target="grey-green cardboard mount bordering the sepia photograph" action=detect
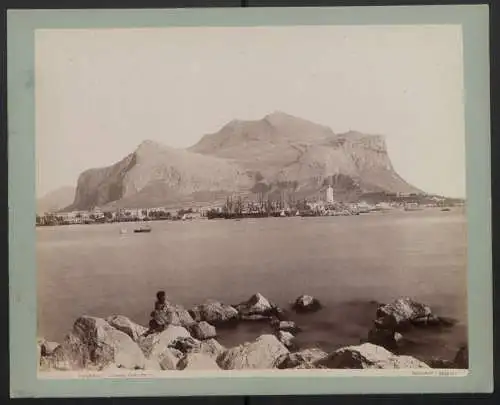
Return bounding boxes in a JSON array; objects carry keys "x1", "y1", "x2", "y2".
[{"x1": 7, "y1": 5, "x2": 493, "y2": 397}]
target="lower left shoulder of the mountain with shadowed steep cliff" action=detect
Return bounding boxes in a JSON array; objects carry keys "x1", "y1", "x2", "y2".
[{"x1": 69, "y1": 141, "x2": 252, "y2": 209}]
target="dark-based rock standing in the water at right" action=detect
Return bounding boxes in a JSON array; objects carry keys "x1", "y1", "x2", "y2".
[{"x1": 375, "y1": 298, "x2": 439, "y2": 331}]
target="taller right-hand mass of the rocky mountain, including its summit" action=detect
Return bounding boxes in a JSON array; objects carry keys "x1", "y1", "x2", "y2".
[{"x1": 190, "y1": 112, "x2": 419, "y2": 197}]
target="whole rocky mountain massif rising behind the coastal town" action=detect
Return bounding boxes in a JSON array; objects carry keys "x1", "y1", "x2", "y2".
[{"x1": 64, "y1": 112, "x2": 420, "y2": 209}]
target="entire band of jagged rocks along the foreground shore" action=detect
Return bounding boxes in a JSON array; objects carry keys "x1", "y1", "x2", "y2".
[{"x1": 37, "y1": 294, "x2": 468, "y2": 371}]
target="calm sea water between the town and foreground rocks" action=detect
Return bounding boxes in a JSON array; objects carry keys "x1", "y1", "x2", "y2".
[{"x1": 37, "y1": 209, "x2": 466, "y2": 358}]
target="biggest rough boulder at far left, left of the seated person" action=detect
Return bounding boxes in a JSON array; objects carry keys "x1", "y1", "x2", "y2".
[{"x1": 46, "y1": 316, "x2": 151, "y2": 370}]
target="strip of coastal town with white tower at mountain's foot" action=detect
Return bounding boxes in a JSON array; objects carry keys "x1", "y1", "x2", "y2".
[{"x1": 36, "y1": 186, "x2": 463, "y2": 226}]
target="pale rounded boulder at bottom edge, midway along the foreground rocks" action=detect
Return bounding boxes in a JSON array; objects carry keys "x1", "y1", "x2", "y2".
[{"x1": 217, "y1": 335, "x2": 289, "y2": 370}]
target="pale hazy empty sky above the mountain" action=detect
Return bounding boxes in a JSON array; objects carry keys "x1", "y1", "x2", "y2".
[{"x1": 35, "y1": 25, "x2": 465, "y2": 196}]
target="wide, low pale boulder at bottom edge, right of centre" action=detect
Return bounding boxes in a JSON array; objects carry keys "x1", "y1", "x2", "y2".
[{"x1": 315, "y1": 343, "x2": 430, "y2": 369}]
